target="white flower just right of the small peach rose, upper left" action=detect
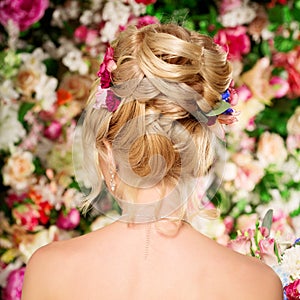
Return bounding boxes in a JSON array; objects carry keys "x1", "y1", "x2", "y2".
[{"x1": 35, "y1": 74, "x2": 58, "y2": 111}]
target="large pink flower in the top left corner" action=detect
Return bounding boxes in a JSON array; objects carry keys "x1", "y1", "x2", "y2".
[{"x1": 0, "y1": 0, "x2": 49, "y2": 31}]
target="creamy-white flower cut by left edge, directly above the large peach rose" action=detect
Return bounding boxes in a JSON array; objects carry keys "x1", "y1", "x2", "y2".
[{"x1": 0, "y1": 104, "x2": 26, "y2": 150}]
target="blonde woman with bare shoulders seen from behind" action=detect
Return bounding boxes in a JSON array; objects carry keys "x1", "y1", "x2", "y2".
[{"x1": 22, "y1": 24, "x2": 282, "y2": 300}]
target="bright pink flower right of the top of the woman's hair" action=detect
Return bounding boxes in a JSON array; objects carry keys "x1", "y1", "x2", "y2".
[{"x1": 214, "y1": 26, "x2": 251, "y2": 60}]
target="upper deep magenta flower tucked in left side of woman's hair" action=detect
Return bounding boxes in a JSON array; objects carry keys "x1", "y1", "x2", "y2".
[{"x1": 97, "y1": 47, "x2": 116, "y2": 89}]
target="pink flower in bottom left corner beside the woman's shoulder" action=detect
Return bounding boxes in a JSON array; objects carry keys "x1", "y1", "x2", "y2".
[{"x1": 3, "y1": 267, "x2": 26, "y2": 300}]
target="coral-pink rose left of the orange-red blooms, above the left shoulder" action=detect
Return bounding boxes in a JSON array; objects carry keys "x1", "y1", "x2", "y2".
[{"x1": 12, "y1": 203, "x2": 40, "y2": 231}]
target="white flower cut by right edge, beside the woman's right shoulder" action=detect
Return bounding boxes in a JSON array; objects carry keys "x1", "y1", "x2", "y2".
[{"x1": 281, "y1": 245, "x2": 300, "y2": 279}]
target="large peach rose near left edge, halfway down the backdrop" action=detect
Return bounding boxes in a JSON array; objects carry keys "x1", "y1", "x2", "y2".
[{"x1": 3, "y1": 151, "x2": 35, "y2": 190}]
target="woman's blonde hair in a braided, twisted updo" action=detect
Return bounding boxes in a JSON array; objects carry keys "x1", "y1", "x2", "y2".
[{"x1": 83, "y1": 24, "x2": 232, "y2": 230}]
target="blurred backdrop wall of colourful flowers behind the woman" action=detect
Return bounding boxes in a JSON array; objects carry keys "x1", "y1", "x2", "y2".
[{"x1": 0, "y1": 0, "x2": 300, "y2": 299}]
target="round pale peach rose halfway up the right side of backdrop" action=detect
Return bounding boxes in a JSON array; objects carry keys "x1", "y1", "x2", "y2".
[{"x1": 256, "y1": 131, "x2": 287, "y2": 166}]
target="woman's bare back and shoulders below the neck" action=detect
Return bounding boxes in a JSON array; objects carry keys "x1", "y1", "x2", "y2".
[{"x1": 22, "y1": 145, "x2": 283, "y2": 300}]
